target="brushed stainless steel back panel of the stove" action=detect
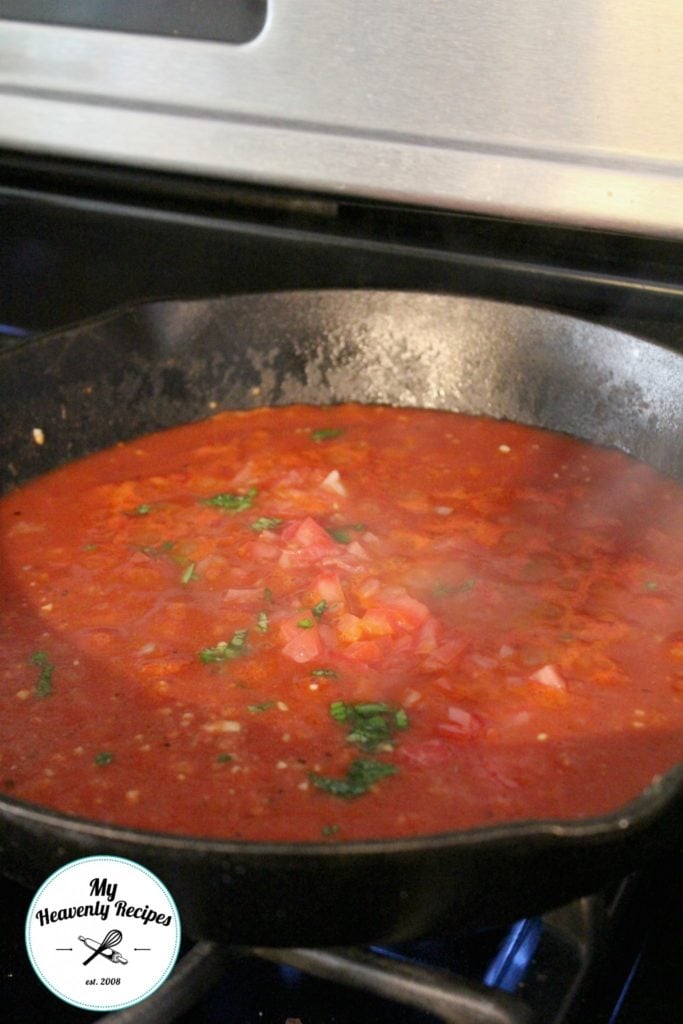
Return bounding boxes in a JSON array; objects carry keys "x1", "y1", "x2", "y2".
[{"x1": 0, "y1": 0, "x2": 683, "y2": 236}]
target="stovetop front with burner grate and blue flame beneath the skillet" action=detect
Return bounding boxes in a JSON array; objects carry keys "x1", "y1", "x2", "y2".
[{"x1": 0, "y1": 858, "x2": 683, "y2": 1024}]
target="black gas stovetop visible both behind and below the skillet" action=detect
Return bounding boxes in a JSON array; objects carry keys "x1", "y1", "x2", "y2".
[{"x1": 0, "y1": 154, "x2": 683, "y2": 1024}]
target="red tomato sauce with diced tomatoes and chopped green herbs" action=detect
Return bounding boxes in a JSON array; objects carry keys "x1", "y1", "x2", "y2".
[{"x1": 0, "y1": 404, "x2": 683, "y2": 841}]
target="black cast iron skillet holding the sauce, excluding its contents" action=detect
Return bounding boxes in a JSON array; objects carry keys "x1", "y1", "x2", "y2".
[{"x1": 0, "y1": 292, "x2": 683, "y2": 946}]
